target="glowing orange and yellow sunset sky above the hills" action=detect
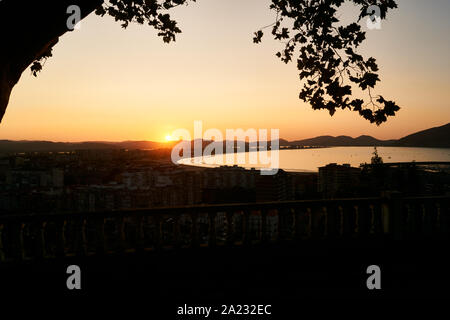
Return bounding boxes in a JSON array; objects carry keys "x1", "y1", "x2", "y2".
[{"x1": 0, "y1": 0, "x2": 450, "y2": 141}]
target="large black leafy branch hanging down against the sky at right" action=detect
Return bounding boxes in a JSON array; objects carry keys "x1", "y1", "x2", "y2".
[{"x1": 253, "y1": 0, "x2": 400, "y2": 125}]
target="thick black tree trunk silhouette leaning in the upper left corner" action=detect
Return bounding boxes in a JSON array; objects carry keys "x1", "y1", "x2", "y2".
[{"x1": 0, "y1": 0, "x2": 103, "y2": 122}]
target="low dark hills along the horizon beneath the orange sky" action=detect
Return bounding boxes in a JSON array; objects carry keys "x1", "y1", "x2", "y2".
[{"x1": 0, "y1": 123, "x2": 450, "y2": 153}]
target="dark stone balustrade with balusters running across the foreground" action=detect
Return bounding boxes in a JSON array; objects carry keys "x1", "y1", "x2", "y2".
[{"x1": 0, "y1": 196, "x2": 450, "y2": 264}]
